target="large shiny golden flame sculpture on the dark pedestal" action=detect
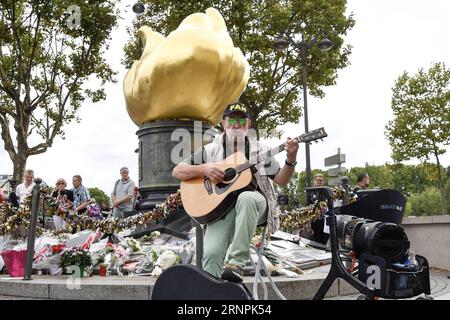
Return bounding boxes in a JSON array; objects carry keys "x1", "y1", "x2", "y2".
[{"x1": 123, "y1": 8, "x2": 250, "y2": 125}]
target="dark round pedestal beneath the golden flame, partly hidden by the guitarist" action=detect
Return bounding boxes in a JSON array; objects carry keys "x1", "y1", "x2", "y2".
[{"x1": 136, "y1": 120, "x2": 213, "y2": 210}]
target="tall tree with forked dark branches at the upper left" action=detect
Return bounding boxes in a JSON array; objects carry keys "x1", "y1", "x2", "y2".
[{"x1": 0, "y1": 0, "x2": 118, "y2": 181}]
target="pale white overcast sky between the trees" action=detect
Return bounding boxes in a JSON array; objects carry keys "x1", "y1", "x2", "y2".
[{"x1": 0, "y1": 0, "x2": 450, "y2": 193}]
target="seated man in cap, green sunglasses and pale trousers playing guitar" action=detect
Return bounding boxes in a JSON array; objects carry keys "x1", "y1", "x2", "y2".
[{"x1": 172, "y1": 104, "x2": 298, "y2": 282}]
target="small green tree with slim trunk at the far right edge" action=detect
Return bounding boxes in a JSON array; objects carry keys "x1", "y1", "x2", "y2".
[{"x1": 386, "y1": 63, "x2": 450, "y2": 214}]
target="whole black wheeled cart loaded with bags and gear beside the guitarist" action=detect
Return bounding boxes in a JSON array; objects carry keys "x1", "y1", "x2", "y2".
[{"x1": 307, "y1": 187, "x2": 430, "y2": 299}]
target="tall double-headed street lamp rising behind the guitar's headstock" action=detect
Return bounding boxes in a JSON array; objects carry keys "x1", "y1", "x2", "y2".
[{"x1": 273, "y1": 27, "x2": 333, "y2": 187}]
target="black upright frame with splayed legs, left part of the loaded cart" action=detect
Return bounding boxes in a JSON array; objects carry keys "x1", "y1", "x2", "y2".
[{"x1": 306, "y1": 187, "x2": 374, "y2": 300}]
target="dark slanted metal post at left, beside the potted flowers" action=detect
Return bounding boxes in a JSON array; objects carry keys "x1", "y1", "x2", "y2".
[{"x1": 23, "y1": 178, "x2": 42, "y2": 280}]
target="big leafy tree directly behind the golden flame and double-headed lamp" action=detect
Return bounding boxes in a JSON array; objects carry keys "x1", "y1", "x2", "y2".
[{"x1": 123, "y1": 0, "x2": 354, "y2": 136}]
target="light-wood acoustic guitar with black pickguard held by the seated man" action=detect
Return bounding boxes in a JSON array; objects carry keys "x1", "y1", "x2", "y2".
[{"x1": 180, "y1": 128, "x2": 327, "y2": 224}]
